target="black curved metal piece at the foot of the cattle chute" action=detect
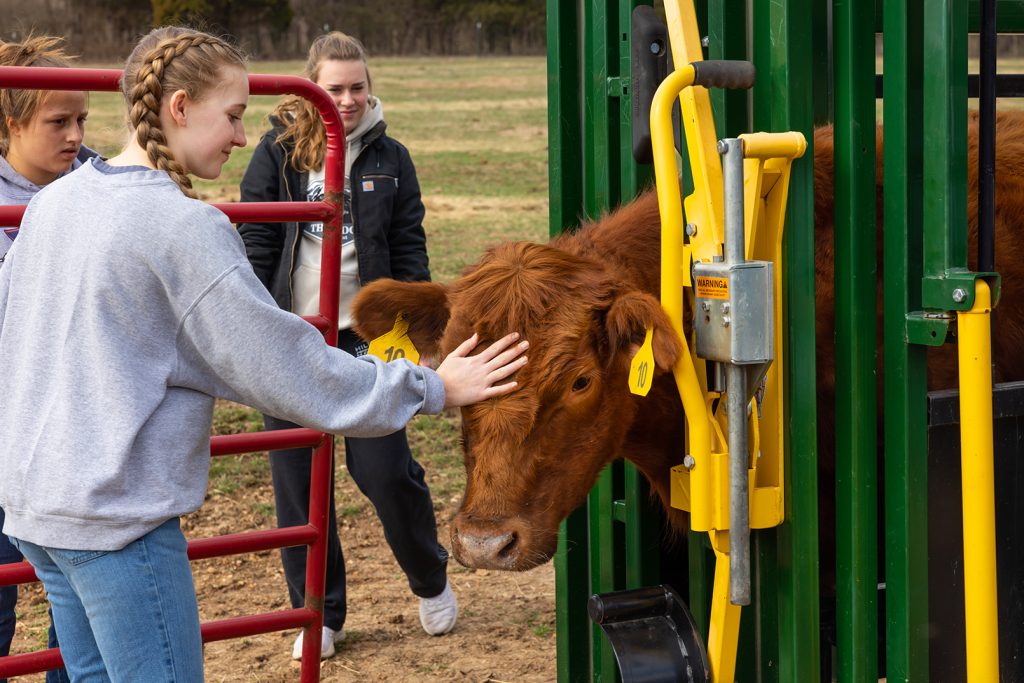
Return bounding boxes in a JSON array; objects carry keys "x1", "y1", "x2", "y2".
[{"x1": 587, "y1": 585, "x2": 711, "y2": 683}]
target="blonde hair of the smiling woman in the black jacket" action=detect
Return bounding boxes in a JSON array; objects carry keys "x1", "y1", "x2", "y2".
[{"x1": 271, "y1": 31, "x2": 373, "y2": 171}]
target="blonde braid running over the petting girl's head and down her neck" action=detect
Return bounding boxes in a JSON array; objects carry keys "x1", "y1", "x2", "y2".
[{"x1": 126, "y1": 32, "x2": 242, "y2": 199}]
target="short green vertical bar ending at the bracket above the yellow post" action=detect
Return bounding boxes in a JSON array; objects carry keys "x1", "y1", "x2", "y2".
[{"x1": 923, "y1": 0, "x2": 967, "y2": 274}]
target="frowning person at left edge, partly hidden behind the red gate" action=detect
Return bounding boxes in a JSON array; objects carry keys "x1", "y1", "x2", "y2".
[{"x1": 0, "y1": 35, "x2": 96, "y2": 683}]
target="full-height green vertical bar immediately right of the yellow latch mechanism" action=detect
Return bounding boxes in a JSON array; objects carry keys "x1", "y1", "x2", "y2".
[{"x1": 753, "y1": 0, "x2": 820, "y2": 681}]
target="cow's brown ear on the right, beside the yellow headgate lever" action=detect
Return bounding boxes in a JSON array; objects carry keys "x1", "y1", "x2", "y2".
[{"x1": 605, "y1": 290, "x2": 683, "y2": 372}]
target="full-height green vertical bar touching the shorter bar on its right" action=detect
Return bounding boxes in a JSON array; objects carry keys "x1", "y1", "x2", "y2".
[{"x1": 883, "y1": 0, "x2": 935, "y2": 683}]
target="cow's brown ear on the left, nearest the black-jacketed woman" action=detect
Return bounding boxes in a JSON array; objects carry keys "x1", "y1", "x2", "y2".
[{"x1": 352, "y1": 280, "x2": 451, "y2": 356}]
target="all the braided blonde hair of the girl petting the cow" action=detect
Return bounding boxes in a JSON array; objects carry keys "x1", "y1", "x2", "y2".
[{"x1": 121, "y1": 27, "x2": 246, "y2": 199}]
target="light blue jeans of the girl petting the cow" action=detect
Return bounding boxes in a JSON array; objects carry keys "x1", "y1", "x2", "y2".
[{"x1": 11, "y1": 517, "x2": 203, "y2": 683}]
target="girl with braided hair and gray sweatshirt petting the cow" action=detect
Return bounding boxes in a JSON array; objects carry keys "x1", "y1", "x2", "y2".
[{"x1": 0, "y1": 28, "x2": 526, "y2": 683}]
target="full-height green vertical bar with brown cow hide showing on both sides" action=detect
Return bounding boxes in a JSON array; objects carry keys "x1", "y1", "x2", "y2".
[{"x1": 833, "y1": 0, "x2": 879, "y2": 683}]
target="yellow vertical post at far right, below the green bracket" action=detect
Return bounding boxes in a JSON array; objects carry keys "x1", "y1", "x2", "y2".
[{"x1": 956, "y1": 280, "x2": 999, "y2": 683}]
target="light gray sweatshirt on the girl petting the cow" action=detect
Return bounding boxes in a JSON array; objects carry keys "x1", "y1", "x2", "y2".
[{"x1": 0, "y1": 159, "x2": 444, "y2": 550}]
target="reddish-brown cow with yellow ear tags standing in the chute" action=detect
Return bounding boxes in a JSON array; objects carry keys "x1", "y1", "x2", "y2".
[{"x1": 354, "y1": 113, "x2": 1024, "y2": 570}]
